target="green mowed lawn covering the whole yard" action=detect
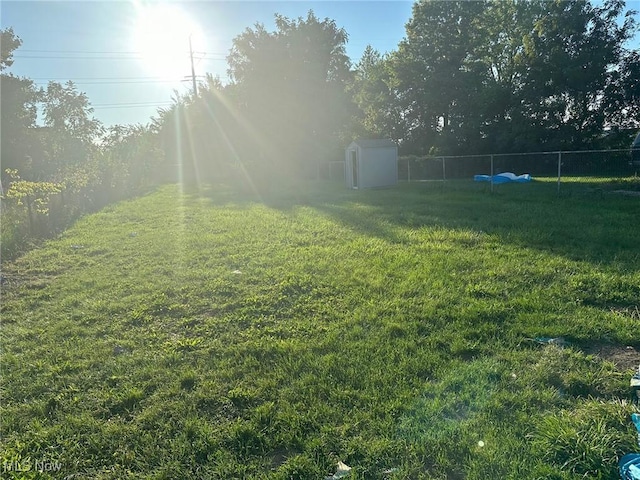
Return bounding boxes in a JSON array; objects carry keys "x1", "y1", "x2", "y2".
[{"x1": 1, "y1": 182, "x2": 640, "y2": 480}]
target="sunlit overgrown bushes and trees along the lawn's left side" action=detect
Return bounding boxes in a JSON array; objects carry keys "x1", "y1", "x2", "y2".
[{"x1": 0, "y1": 29, "x2": 164, "y2": 260}]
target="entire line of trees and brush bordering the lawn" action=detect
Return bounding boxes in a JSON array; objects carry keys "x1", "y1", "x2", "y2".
[{"x1": 0, "y1": 0, "x2": 640, "y2": 254}]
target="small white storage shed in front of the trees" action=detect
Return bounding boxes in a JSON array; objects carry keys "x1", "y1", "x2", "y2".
[{"x1": 344, "y1": 139, "x2": 398, "y2": 188}]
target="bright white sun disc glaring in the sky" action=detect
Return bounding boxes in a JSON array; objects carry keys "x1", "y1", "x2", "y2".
[{"x1": 132, "y1": 4, "x2": 203, "y2": 81}]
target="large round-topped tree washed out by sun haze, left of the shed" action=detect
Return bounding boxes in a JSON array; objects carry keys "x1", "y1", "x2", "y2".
[{"x1": 228, "y1": 11, "x2": 351, "y2": 177}]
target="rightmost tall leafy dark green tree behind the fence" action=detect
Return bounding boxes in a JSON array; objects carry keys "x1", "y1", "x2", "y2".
[{"x1": 521, "y1": 0, "x2": 634, "y2": 148}]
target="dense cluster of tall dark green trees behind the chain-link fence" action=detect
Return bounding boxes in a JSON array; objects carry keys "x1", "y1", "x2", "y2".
[{"x1": 392, "y1": 0, "x2": 637, "y2": 153}]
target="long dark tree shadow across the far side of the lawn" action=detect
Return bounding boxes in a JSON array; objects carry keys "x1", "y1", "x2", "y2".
[{"x1": 185, "y1": 179, "x2": 640, "y2": 270}]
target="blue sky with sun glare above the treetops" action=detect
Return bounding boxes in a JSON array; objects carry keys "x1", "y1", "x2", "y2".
[{"x1": 0, "y1": 0, "x2": 640, "y2": 126}]
